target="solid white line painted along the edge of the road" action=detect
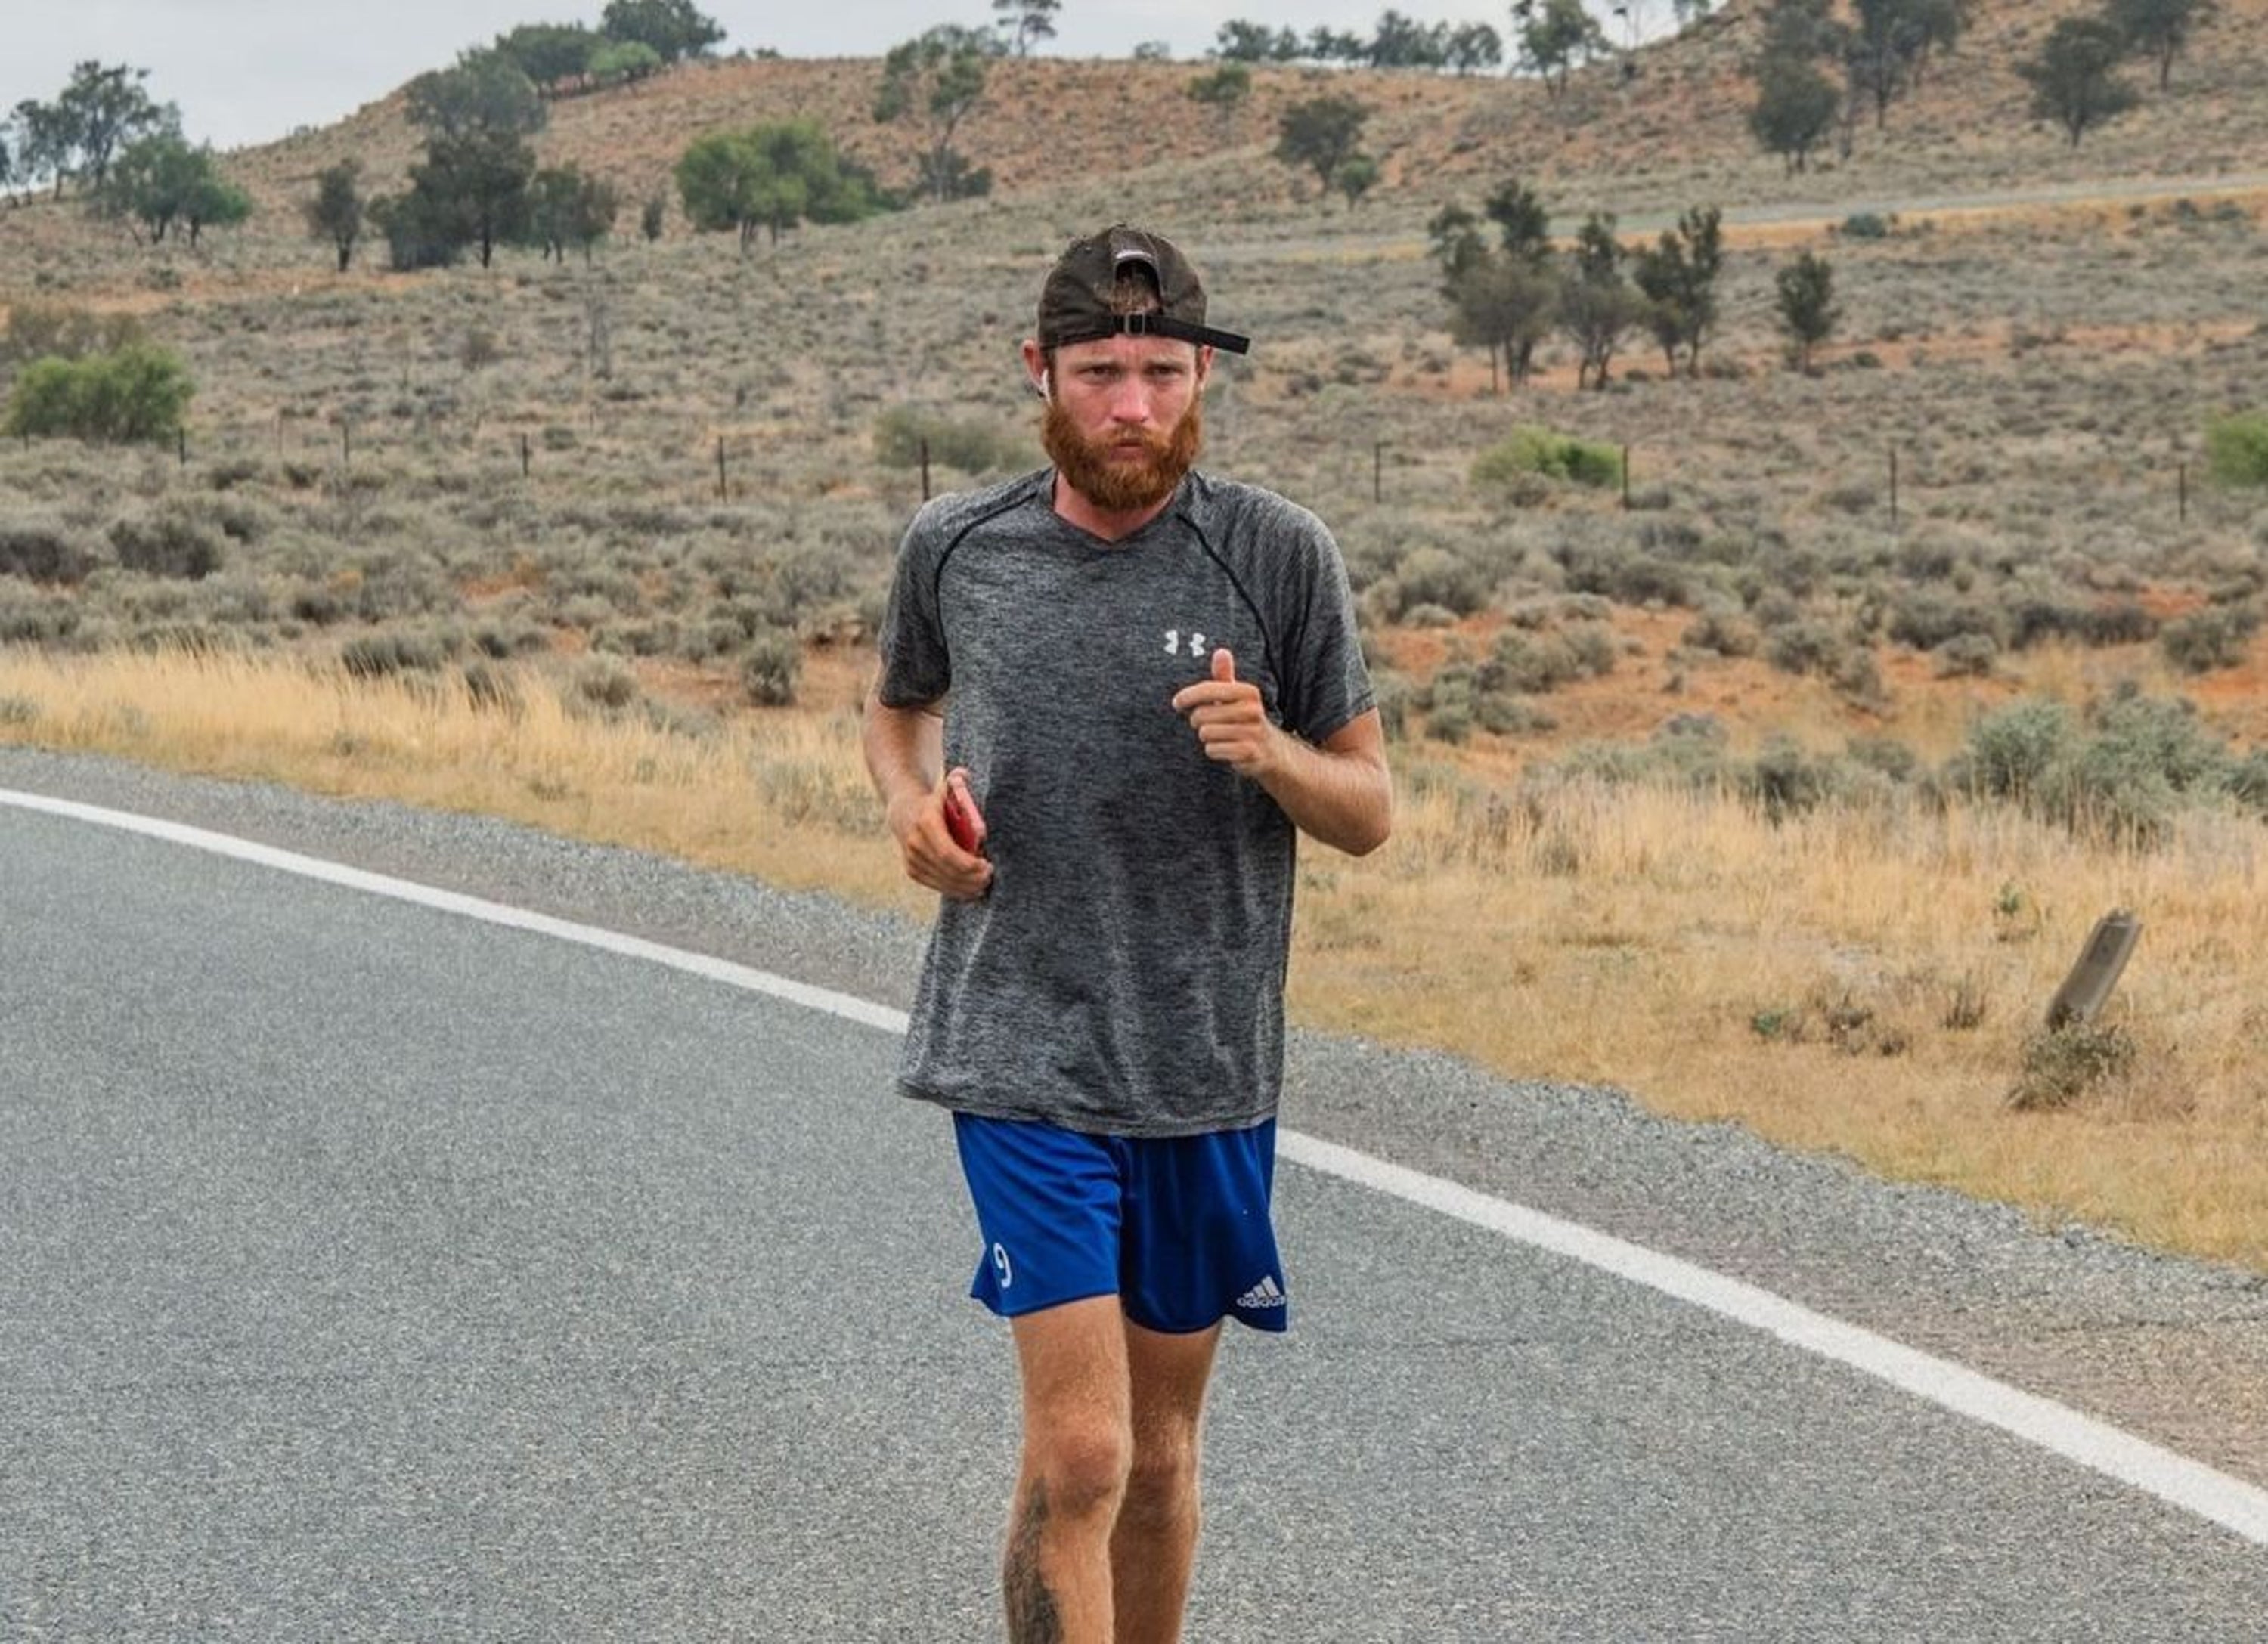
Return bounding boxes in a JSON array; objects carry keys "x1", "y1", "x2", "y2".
[{"x1": 0, "y1": 789, "x2": 2268, "y2": 1546}]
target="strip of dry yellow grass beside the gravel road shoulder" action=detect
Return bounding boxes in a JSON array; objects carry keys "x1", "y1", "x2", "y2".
[{"x1": 0, "y1": 651, "x2": 2268, "y2": 1270}]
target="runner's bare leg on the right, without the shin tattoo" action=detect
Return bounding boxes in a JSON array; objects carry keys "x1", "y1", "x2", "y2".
[{"x1": 1111, "y1": 1320, "x2": 1220, "y2": 1644}]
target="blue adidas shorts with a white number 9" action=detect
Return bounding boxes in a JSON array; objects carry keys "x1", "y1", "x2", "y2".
[{"x1": 953, "y1": 1113, "x2": 1290, "y2": 1333}]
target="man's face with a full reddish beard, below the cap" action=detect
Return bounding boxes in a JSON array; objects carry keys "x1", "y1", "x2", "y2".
[{"x1": 1041, "y1": 336, "x2": 1211, "y2": 512}]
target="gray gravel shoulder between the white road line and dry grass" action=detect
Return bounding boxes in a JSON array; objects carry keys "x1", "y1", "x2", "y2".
[{"x1": 0, "y1": 748, "x2": 2268, "y2": 1485}]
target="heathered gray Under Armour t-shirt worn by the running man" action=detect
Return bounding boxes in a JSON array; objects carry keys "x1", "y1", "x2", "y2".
[{"x1": 880, "y1": 469, "x2": 1372, "y2": 1136}]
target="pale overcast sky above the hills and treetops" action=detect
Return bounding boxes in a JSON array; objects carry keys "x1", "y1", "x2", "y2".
[{"x1": 0, "y1": 0, "x2": 1669, "y2": 147}]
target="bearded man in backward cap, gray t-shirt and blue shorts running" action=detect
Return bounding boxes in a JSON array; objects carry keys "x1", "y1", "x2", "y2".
[{"x1": 864, "y1": 227, "x2": 1393, "y2": 1644}]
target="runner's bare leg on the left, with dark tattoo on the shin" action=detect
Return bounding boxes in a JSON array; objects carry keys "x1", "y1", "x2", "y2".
[{"x1": 1002, "y1": 1295, "x2": 1134, "y2": 1644}]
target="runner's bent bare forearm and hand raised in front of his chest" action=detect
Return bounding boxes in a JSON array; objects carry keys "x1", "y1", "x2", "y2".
[{"x1": 1173, "y1": 651, "x2": 1395, "y2": 857}]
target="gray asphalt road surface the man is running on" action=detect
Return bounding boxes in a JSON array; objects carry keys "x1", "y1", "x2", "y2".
[{"x1": 0, "y1": 764, "x2": 2268, "y2": 1644}]
